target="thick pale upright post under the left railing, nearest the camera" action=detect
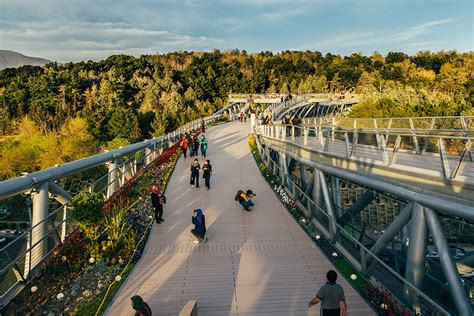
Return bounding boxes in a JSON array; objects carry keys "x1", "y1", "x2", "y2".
[{"x1": 25, "y1": 183, "x2": 49, "y2": 276}]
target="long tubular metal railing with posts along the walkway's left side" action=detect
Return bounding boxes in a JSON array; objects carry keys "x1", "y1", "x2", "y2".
[{"x1": 0, "y1": 115, "x2": 225, "y2": 305}]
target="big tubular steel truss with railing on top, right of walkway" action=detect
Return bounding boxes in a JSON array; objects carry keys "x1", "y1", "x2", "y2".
[{"x1": 254, "y1": 118, "x2": 474, "y2": 315}]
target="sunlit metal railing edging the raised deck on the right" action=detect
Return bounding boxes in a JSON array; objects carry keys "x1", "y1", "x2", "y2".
[{"x1": 258, "y1": 125, "x2": 474, "y2": 183}]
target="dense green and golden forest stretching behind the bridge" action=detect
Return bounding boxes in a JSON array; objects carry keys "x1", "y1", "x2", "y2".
[{"x1": 0, "y1": 50, "x2": 474, "y2": 180}]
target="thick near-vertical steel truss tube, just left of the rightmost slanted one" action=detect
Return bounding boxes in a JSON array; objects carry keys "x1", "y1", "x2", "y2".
[{"x1": 405, "y1": 203, "x2": 428, "y2": 311}]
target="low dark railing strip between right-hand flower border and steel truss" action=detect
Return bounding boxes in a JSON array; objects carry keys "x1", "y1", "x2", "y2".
[{"x1": 257, "y1": 138, "x2": 451, "y2": 315}]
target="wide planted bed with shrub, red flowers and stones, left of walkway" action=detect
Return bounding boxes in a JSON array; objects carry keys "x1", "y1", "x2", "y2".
[{"x1": 4, "y1": 144, "x2": 181, "y2": 315}]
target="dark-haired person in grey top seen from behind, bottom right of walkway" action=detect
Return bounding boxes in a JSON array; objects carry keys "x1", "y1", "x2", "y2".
[{"x1": 308, "y1": 270, "x2": 347, "y2": 316}]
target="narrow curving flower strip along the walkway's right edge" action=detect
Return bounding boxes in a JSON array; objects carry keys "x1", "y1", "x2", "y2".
[{"x1": 249, "y1": 134, "x2": 411, "y2": 316}]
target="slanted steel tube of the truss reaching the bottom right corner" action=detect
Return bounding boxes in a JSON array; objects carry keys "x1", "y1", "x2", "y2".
[{"x1": 424, "y1": 207, "x2": 472, "y2": 315}]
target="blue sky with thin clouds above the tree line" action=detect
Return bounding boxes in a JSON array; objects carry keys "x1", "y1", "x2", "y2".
[{"x1": 0, "y1": 0, "x2": 474, "y2": 62}]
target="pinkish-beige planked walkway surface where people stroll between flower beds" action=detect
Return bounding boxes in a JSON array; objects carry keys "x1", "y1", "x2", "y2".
[{"x1": 107, "y1": 122, "x2": 374, "y2": 315}]
